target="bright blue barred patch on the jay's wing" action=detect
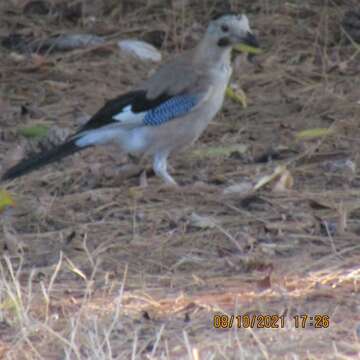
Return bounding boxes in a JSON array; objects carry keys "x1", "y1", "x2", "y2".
[{"x1": 143, "y1": 95, "x2": 198, "y2": 126}]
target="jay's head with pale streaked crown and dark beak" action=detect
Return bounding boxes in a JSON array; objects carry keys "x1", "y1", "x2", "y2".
[{"x1": 207, "y1": 14, "x2": 260, "y2": 49}]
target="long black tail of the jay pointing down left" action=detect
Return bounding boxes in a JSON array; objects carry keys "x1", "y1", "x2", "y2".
[{"x1": 2, "y1": 140, "x2": 86, "y2": 180}]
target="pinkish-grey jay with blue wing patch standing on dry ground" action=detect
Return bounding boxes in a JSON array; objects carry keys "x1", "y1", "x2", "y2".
[{"x1": 2, "y1": 14, "x2": 259, "y2": 185}]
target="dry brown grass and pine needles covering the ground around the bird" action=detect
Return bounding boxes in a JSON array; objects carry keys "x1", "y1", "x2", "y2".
[{"x1": 0, "y1": 0, "x2": 360, "y2": 360}]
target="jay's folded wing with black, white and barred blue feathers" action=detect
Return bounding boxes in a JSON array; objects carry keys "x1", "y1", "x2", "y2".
[{"x1": 74, "y1": 59, "x2": 213, "y2": 137}]
